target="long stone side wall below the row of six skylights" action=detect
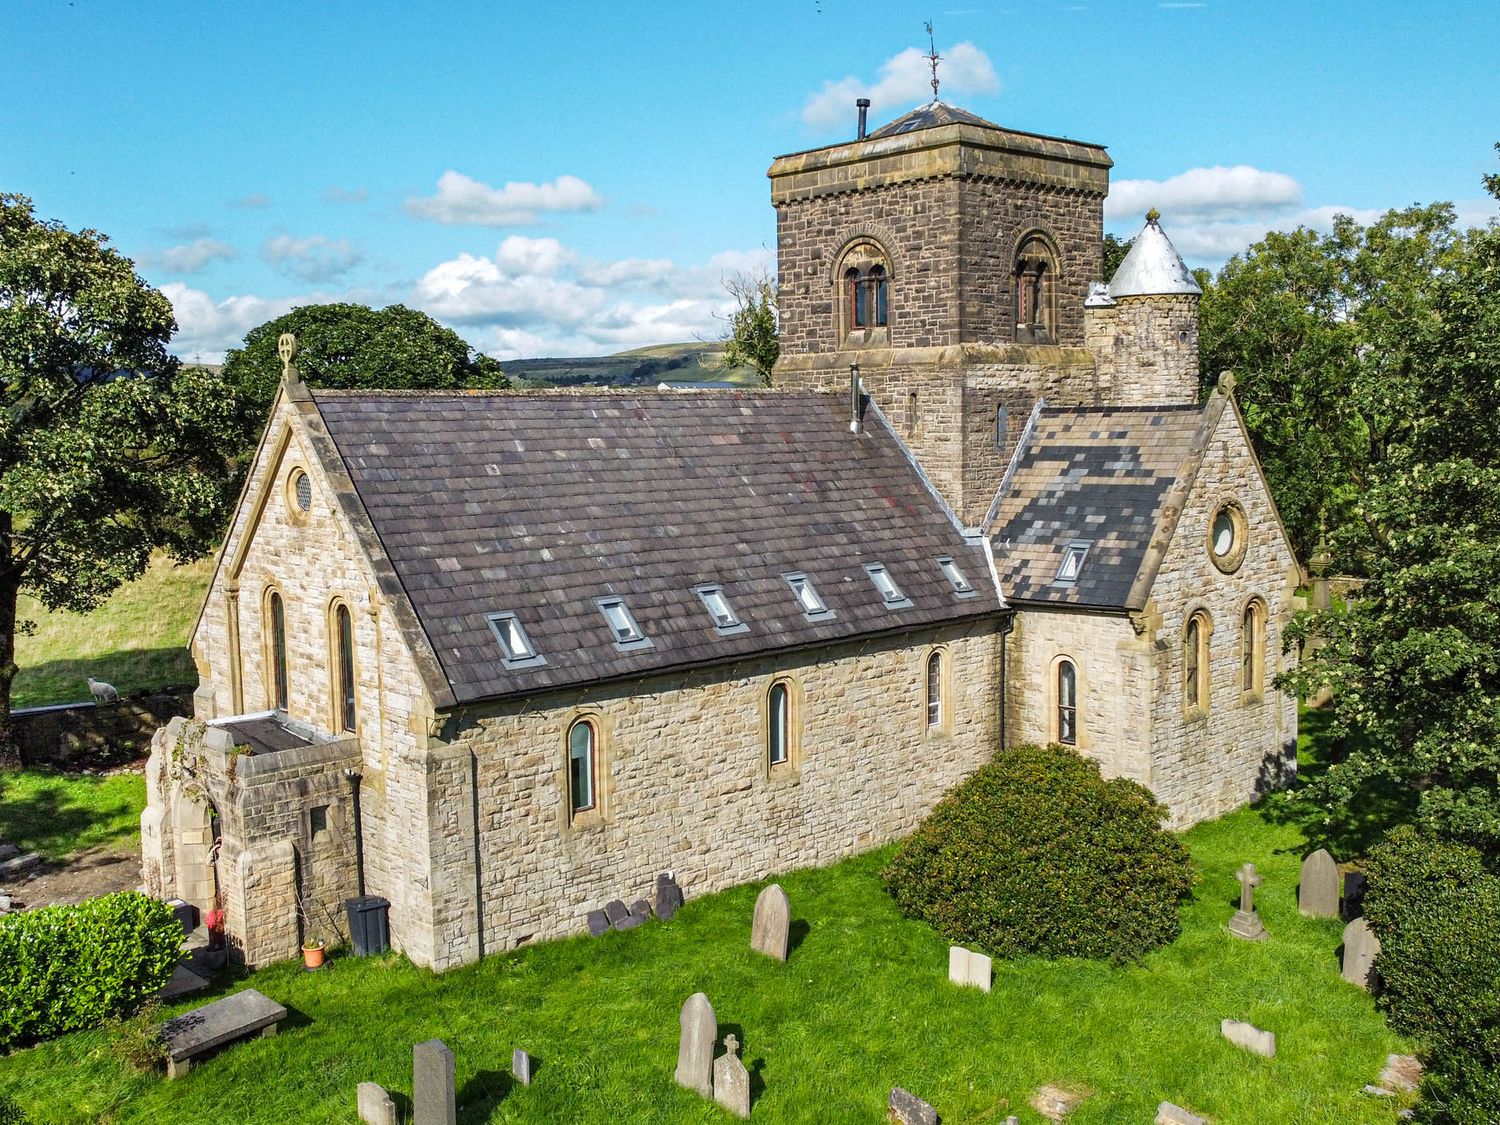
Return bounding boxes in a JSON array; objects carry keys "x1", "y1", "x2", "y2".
[{"x1": 408, "y1": 621, "x2": 999, "y2": 968}]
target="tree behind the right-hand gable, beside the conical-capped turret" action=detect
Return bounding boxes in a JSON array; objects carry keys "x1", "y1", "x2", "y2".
[{"x1": 1199, "y1": 203, "x2": 1464, "y2": 567}]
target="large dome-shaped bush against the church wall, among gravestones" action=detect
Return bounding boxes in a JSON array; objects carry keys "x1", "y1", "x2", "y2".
[{"x1": 884, "y1": 746, "x2": 1193, "y2": 962}]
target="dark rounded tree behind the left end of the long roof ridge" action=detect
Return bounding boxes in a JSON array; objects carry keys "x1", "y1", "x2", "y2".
[{"x1": 224, "y1": 305, "x2": 510, "y2": 431}]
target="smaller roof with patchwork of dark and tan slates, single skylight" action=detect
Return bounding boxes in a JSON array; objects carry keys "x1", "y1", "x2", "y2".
[{"x1": 990, "y1": 405, "x2": 1227, "y2": 609}]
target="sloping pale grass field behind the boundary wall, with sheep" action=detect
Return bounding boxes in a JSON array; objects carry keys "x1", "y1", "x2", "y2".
[{"x1": 11, "y1": 558, "x2": 213, "y2": 707}]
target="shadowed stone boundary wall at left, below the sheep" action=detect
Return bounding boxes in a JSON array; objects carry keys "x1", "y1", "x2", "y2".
[{"x1": 11, "y1": 687, "x2": 192, "y2": 770}]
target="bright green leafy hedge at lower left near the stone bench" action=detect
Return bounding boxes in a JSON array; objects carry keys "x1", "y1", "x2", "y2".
[{"x1": 0, "y1": 891, "x2": 183, "y2": 1049}]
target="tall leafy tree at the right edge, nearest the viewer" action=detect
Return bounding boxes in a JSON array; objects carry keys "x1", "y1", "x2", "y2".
[{"x1": 1284, "y1": 152, "x2": 1500, "y2": 861}]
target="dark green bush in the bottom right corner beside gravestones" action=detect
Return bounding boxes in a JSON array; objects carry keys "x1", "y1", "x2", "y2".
[{"x1": 1365, "y1": 827, "x2": 1500, "y2": 1122}]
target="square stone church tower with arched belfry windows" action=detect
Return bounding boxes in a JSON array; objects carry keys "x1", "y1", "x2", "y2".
[{"x1": 770, "y1": 102, "x2": 1112, "y2": 525}]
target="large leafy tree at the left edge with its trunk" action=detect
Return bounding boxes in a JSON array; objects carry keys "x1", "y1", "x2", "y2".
[{"x1": 0, "y1": 195, "x2": 242, "y2": 749}]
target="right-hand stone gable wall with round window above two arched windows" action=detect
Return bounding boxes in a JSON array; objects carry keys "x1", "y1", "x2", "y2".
[{"x1": 1148, "y1": 402, "x2": 1301, "y2": 827}]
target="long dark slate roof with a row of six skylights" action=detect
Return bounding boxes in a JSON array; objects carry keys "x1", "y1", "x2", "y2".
[{"x1": 314, "y1": 392, "x2": 1002, "y2": 704}]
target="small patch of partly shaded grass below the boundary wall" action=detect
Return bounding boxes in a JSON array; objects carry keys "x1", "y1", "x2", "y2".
[{"x1": 0, "y1": 770, "x2": 146, "y2": 860}]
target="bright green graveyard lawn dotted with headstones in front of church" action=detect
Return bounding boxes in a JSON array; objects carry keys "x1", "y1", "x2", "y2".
[{"x1": 0, "y1": 810, "x2": 1404, "y2": 1125}]
